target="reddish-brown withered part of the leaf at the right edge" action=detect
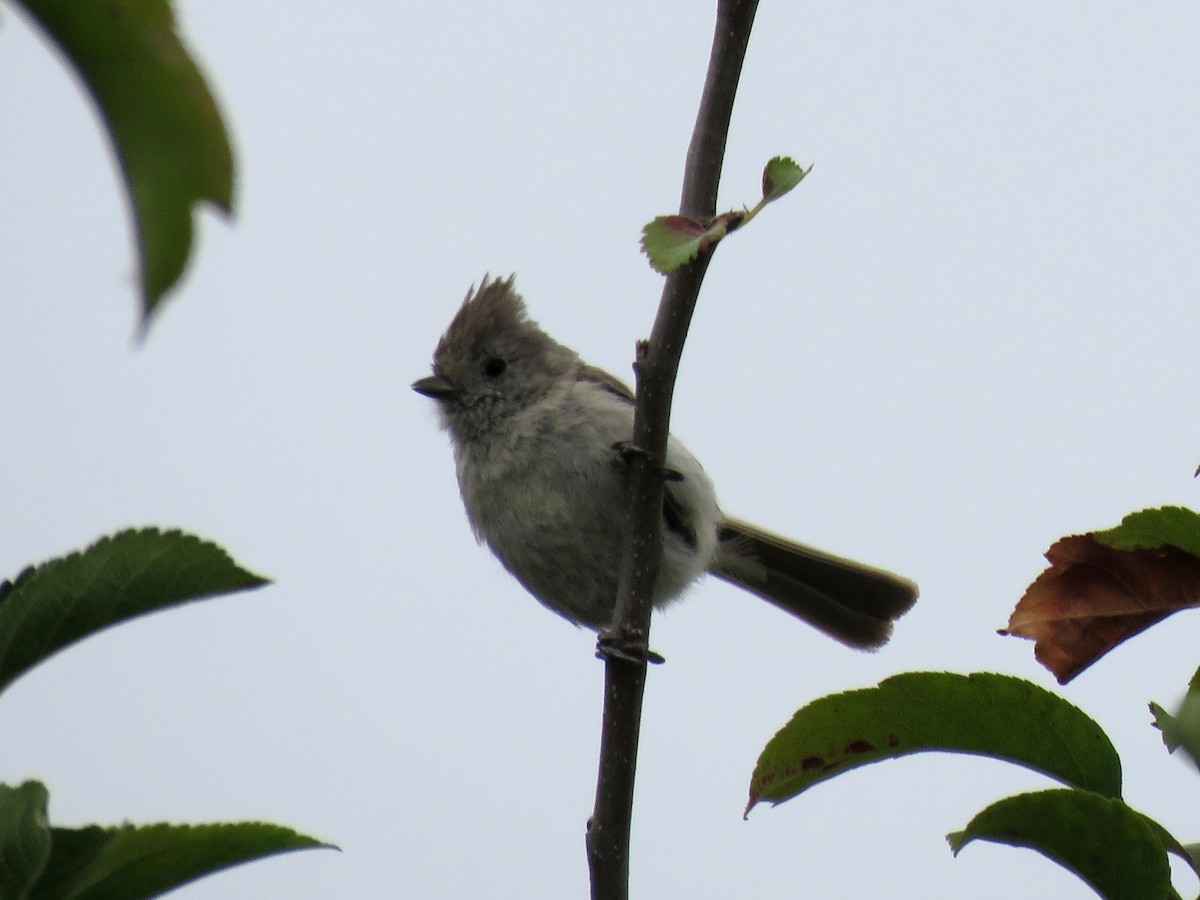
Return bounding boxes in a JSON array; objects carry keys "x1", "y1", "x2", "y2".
[{"x1": 1001, "y1": 534, "x2": 1200, "y2": 684}]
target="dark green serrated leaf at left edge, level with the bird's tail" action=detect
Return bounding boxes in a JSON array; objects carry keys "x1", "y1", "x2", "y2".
[{"x1": 0, "y1": 528, "x2": 268, "y2": 691}]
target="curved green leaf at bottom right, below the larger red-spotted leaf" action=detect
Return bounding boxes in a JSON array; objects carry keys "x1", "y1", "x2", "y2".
[{"x1": 947, "y1": 788, "x2": 1172, "y2": 900}]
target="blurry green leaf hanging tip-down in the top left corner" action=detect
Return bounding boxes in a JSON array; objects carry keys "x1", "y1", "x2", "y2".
[{"x1": 14, "y1": 0, "x2": 234, "y2": 331}]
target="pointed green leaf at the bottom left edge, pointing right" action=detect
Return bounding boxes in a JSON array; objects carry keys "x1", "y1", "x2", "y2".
[{"x1": 39, "y1": 822, "x2": 332, "y2": 900}]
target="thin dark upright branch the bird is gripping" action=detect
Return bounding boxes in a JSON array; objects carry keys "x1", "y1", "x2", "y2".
[{"x1": 587, "y1": 0, "x2": 758, "y2": 900}]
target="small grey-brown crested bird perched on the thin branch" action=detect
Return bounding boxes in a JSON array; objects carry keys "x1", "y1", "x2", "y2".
[{"x1": 413, "y1": 277, "x2": 917, "y2": 648}]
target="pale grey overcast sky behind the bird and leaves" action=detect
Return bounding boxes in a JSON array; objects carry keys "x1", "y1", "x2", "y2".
[{"x1": 0, "y1": 0, "x2": 1200, "y2": 900}]
